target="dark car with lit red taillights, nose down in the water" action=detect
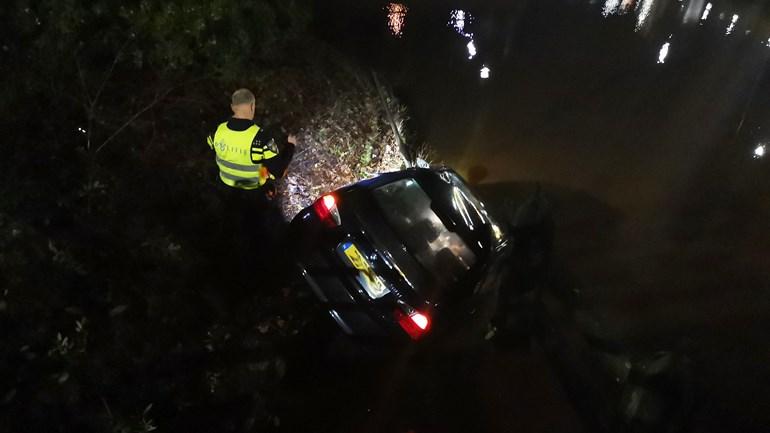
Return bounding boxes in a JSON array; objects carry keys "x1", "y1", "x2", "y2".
[{"x1": 291, "y1": 168, "x2": 510, "y2": 339}]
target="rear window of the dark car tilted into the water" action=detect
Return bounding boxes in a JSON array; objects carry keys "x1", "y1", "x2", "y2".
[{"x1": 373, "y1": 179, "x2": 476, "y2": 287}]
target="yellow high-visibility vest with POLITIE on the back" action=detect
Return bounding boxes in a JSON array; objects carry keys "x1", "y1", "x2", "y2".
[{"x1": 208, "y1": 122, "x2": 277, "y2": 189}]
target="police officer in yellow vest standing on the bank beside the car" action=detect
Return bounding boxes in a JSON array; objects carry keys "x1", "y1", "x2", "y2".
[{"x1": 207, "y1": 89, "x2": 296, "y2": 198}]
